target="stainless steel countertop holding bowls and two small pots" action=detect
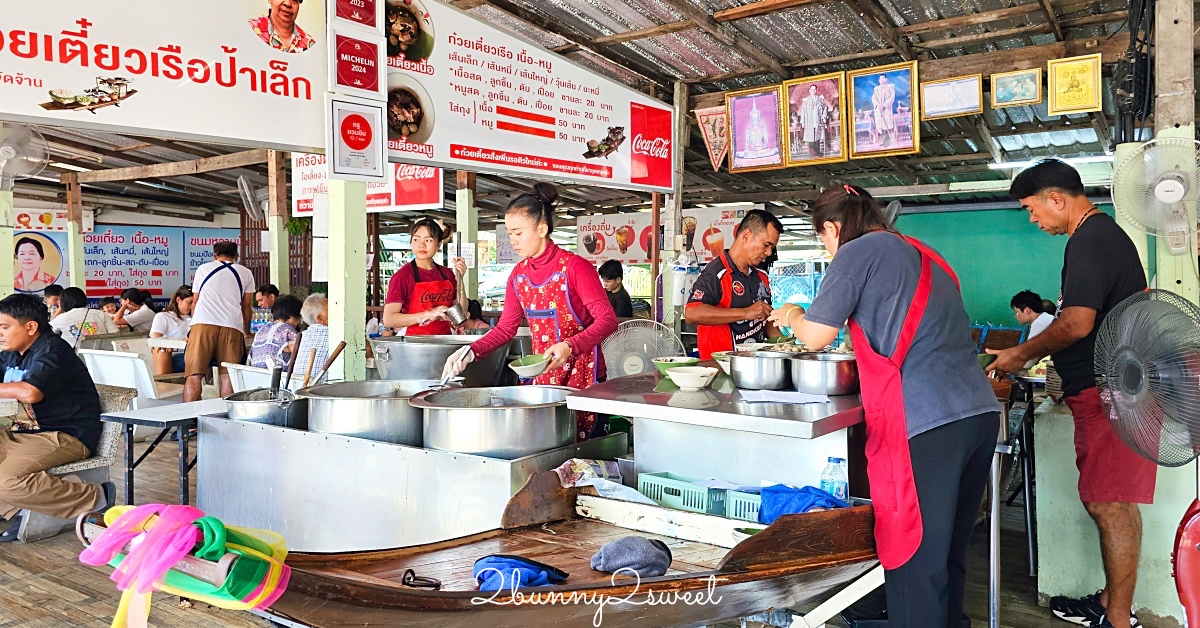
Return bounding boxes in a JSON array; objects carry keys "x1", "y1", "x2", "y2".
[{"x1": 566, "y1": 372, "x2": 863, "y2": 438}]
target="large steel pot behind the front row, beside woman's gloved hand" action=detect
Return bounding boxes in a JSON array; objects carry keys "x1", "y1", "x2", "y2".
[{"x1": 371, "y1": 336, "x2": 508, "y2": 388}]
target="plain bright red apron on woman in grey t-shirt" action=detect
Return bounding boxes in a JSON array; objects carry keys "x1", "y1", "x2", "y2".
[{"x1": 850, "y1": 237, "x2": 959, "y2": 569}]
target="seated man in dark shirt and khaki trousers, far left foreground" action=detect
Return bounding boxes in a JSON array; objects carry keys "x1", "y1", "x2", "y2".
[{"x1": 0, "y1": 294, "x2": 116, "y2": 542}]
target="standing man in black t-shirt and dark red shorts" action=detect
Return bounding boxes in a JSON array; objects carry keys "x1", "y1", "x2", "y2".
[{"x1": 989, "y1": 160, "x2": 1157, "y2": 628}]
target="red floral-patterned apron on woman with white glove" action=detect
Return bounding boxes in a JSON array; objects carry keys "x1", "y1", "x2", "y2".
[{"x1": 512, "y1": 256, "x2": 600, "y2": 441}]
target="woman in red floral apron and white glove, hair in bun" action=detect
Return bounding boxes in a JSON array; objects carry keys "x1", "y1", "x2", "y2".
[{"x1": 443, "y1": 183, "x2": 617, "y2": 441}]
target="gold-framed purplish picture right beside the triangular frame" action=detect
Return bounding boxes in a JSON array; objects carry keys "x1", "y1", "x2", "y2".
[{"x1": 725, "y1": 85, "x2": 786, "y2": 172}]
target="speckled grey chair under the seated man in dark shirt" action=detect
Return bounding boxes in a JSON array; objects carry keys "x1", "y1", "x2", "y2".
[{"x1": 17, "y1": 384, "x2": 138, "y2": 543}]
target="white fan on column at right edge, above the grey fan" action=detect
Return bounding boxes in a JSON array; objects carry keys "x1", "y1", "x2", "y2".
[{"x1": 1112, "y1": 137, "x2": 1200, "y2": 255}]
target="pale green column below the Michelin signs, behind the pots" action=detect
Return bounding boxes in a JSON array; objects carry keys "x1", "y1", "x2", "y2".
[{"x1": 329, "y1": 179, "x2": 367, "y2": 381}]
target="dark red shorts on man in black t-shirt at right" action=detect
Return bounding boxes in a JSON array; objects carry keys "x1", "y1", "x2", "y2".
[{"x1": 1064, "y1": 388, "x2": 1158, "y2": 503}]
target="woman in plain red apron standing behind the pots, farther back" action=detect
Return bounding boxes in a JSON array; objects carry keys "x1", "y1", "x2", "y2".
[{"x1": 383, "y1": 219, "x2": 467, "y2": 336}]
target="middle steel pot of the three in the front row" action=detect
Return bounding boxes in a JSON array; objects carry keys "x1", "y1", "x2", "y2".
[{"x1": 296, "y1": 379, "x2": 462, "y2": 447}]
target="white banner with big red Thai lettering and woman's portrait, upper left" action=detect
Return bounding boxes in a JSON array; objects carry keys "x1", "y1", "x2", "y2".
[{"x1": 0, "y1": 0, "x2": 328, "y2": 150}]
